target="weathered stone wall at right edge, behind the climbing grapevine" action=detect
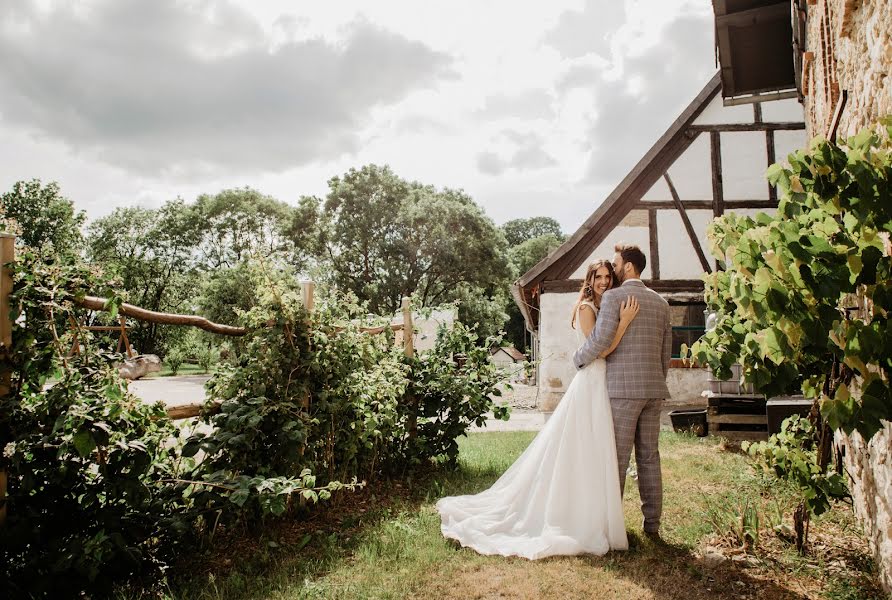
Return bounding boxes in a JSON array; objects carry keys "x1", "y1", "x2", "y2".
[{"x1": 803, "y1": 0, "x2": 892, "y2": 593}]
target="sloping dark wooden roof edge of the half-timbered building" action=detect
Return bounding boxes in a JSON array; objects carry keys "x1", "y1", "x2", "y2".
[{"x1": 514, "y1": 73, "x2": 721, "y2": 288}]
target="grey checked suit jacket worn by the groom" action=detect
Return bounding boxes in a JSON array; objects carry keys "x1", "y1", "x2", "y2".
[{"x1": 573, "y1": 280, "x2": 672, "y2": 399}]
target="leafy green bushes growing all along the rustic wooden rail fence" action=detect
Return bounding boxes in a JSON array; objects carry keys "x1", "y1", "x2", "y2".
[{"x1": 0, "y1": 250, "x2": 504, "y2": 598}]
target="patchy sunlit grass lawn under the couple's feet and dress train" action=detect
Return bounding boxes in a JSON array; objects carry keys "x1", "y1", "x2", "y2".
[{"x1": 120, "y1": 432, "x2": 881, "y2": 600}]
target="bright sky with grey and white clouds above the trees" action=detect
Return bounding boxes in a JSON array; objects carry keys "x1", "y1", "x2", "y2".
[{"x1": 0, "y1": 0, "x2": 715, "y2": 232}]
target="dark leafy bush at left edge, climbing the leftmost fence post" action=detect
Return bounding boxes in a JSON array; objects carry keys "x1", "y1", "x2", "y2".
[{"x1": 0, "y1": 249, "x2": 354, "y2": 598}]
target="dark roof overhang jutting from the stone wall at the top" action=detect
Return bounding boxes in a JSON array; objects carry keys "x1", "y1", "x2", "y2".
[{"x1": 712, "y1": 0, "x2": 799, "y2": 106}]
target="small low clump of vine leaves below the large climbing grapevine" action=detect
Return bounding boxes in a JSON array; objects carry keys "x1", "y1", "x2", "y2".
[{"x1": 743, "y1": 415, "x2": 849, "y2": 516}]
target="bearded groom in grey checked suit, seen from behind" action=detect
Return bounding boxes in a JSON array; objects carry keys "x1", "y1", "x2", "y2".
[{"x1": 573, "y1": 244, "x2": 672, "y2": 538}]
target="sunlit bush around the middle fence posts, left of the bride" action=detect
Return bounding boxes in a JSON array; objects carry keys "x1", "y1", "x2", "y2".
[{"x1": 185, "y1": 270, "x2": 507, "y2": 494}]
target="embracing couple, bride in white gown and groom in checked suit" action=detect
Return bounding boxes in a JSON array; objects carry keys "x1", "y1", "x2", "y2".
[{"x1": 437, "y1": 244, "x2": 672, "y2": 559}]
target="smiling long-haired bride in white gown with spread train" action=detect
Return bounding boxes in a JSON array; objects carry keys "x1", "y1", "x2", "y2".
[{"x1": 437, "y1": 260, "x2": 639, "y2": 559}]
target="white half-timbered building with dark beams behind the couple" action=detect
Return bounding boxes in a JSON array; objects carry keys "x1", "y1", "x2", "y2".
[{"x1": 513, "y1": 74, "x2": 805, "y2": 411}]
